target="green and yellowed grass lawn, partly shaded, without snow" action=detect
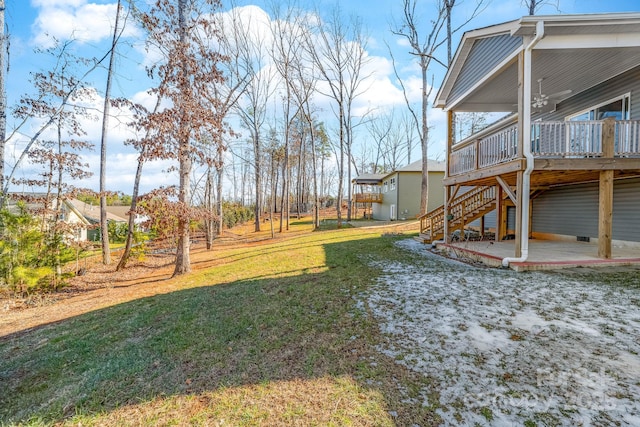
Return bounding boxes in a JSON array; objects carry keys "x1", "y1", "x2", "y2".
[{"x1": 0, "y1": 219, "x2": 438, "y2": 426}]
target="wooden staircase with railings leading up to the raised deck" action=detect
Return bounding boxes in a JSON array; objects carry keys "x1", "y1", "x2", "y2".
[{"x1": 419, "y1": 186, "x2": 496, "y2": 243}]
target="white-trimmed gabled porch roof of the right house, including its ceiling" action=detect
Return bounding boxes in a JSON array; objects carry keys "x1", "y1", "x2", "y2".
[{"x1": 435, "y1": 12, "x2": 640, "y2": 112}]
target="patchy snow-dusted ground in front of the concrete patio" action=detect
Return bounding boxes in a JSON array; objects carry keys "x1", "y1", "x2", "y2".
[{"x1": 363, "y1": 239, "x2": 640, "y2": 426}]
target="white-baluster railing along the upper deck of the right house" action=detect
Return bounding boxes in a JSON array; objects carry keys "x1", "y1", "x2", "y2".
[{"x1": 449, "y1": 120, "x2": 640, "y2": 175}]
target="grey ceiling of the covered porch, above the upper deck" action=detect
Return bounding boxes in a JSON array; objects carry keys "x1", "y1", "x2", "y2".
[{"x1": 455, "y1": 46, "x2": 640, "y2": 112}]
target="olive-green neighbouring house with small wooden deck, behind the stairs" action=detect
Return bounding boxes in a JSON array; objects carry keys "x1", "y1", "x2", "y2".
[{"x1": 352, "y1": 160, "x2": 445, "y2": 221}]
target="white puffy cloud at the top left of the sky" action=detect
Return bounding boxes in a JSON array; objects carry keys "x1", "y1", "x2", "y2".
[{"x1": 32, "y1": 0, "x2": 138, "y2": 48}]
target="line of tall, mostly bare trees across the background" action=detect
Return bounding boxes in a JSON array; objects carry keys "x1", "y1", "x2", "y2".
[{"x1": 0, "y1": 0, "x2": 552, "y2": 288}]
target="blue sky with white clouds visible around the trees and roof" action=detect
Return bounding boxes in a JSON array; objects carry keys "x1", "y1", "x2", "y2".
[{"x1": 5, "y1": 0, "x2": 640, "y2": 194}]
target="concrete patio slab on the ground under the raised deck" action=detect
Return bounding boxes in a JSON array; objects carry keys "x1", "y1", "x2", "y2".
[{"x1": 437, "y1": 239, "x2": 640, "y2": 271}]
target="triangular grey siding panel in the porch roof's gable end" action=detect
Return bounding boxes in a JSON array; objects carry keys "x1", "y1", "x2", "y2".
[{"x1": 450, "y1": 34, "x2": 522, "y2": 99}]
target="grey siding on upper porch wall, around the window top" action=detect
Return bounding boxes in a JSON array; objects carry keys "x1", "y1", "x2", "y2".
[{"x1": 543, "y1": 66, "x2": 640, "y2": 120}]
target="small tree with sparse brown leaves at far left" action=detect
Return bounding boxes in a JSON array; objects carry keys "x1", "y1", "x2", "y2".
[{"x1": 7, "y1": 41, "x2": 94, "y2": 284}]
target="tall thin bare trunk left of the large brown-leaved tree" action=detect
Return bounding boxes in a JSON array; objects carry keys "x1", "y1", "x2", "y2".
[{"x1": 100, "y1": 0, "x2": 121, "y2": 265}]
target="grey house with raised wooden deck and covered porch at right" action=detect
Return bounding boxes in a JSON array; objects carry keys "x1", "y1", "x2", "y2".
[{"x1": 421, "y1": 13, "x2": 640, "y2": 265}]
